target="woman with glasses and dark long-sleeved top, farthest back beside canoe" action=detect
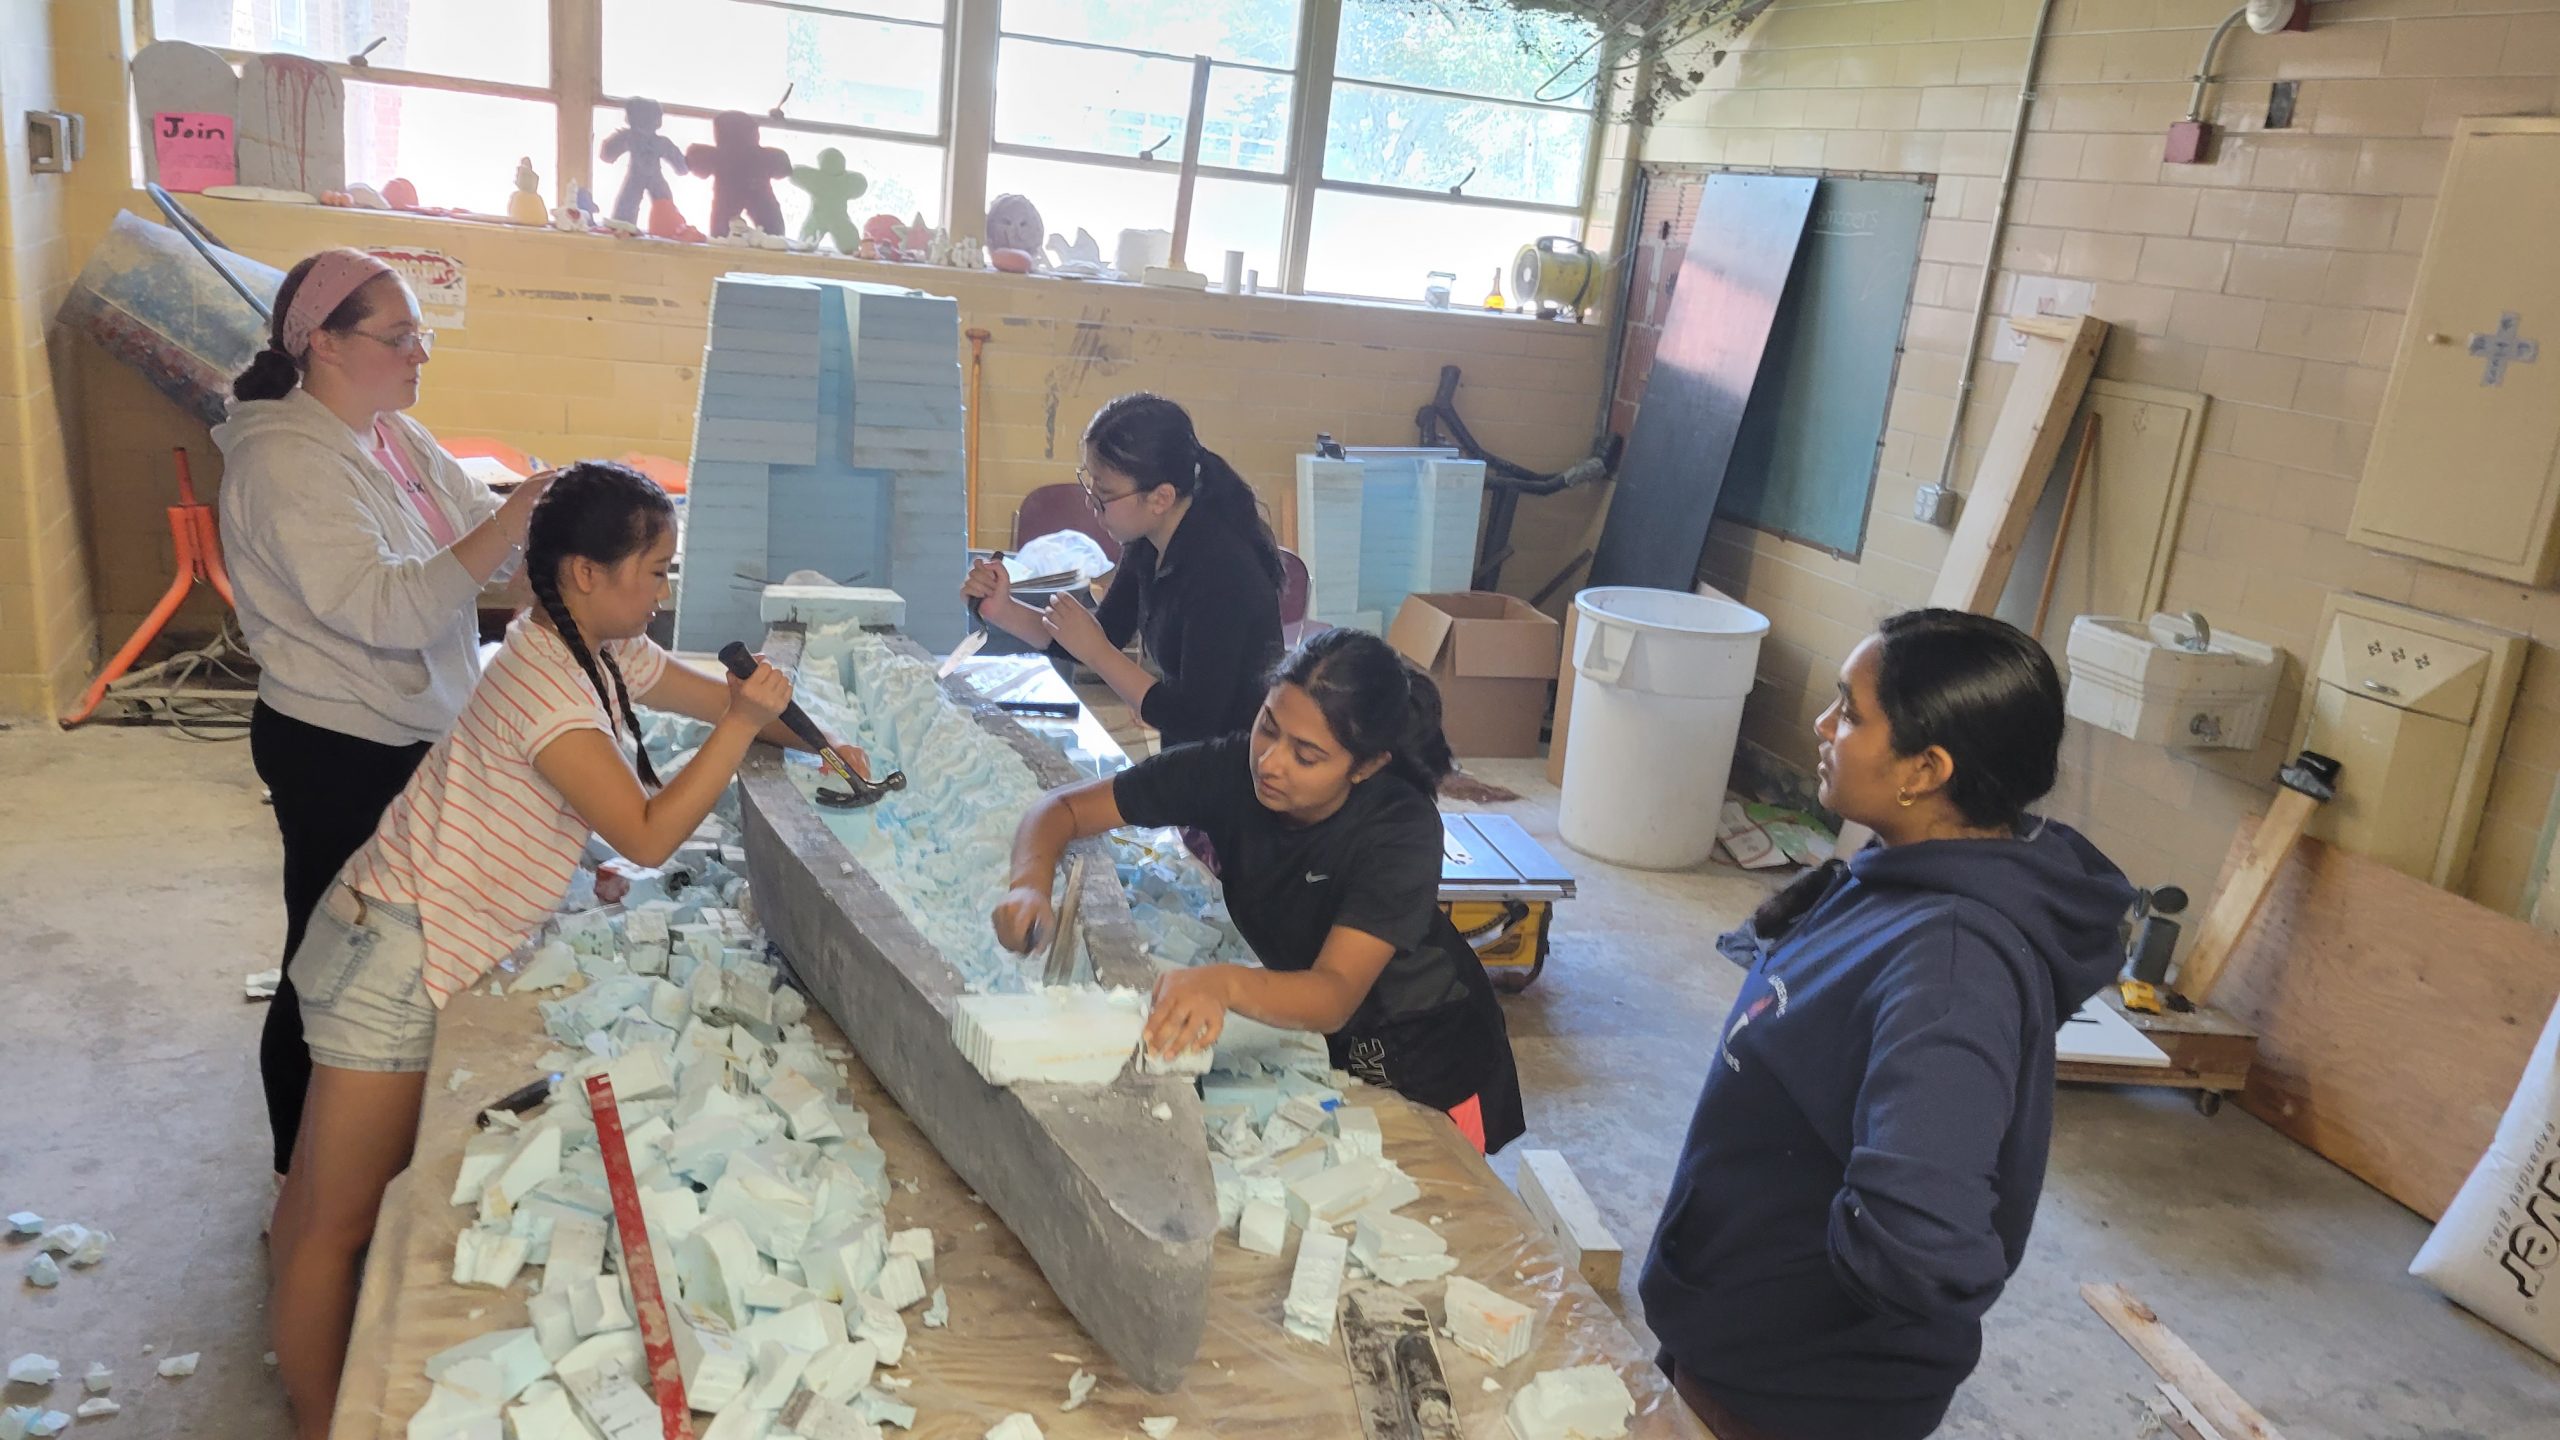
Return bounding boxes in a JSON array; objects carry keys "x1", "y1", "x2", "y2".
[{"x1": 960, "y1": 395, "x2": 1280, "y2": 746}]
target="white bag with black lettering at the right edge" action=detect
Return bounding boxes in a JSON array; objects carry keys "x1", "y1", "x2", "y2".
[{"x1": 2409, "y1": 1004, "x2": 2560, "y2": 1361}]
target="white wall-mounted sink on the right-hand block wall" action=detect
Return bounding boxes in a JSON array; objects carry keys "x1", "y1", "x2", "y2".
[{"x1": 2066, "y1": 612, "x2": 2284, "y2": 751}]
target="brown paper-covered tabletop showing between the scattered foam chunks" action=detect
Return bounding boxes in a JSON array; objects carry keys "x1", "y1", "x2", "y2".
[{"x1": 330, "y1": 976, "x2": 1708, "y2": 1440}]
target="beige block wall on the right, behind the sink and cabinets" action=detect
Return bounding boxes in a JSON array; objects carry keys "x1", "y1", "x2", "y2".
[{"x1": 1631, "y1": 0, "x2": 2560, "y2": 910}]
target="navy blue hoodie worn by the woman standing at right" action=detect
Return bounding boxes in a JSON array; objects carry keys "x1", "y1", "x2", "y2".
[{"x1": 1641, "y1": 820, "x2": 2132, "y2": 1440}]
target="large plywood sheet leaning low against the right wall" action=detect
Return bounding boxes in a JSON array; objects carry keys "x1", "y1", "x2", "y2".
[{"x1": 2220, "y1": 825, "x2": 2560, "y2": 1220}]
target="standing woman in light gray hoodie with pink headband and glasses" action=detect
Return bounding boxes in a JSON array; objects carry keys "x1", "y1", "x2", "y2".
[{"x1": 212, "y1": 249, "x2": 548, "y2": 1179}]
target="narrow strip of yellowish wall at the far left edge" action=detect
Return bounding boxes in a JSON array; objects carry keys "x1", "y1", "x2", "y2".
[{"x1": 0, "y1": 0, "x2": 97, "y2": 717}]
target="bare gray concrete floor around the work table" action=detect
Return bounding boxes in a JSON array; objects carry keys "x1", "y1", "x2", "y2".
[{"x1": 0, "y1": 728, "x2": 2560, "y2": 1440}]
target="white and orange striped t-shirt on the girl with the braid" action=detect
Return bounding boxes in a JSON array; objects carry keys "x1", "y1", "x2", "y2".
[{"x1": 340, "y1": 620, "x2": 666, "y2": 1010}]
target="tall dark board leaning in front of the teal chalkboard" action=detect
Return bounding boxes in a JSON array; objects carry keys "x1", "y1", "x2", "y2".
[{"x1": 1590, "y1": 174, "x2": 1812, "y2": 589}]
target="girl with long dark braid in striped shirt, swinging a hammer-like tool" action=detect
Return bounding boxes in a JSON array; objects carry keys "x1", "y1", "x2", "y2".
[{"x1": 271, "y1": 464, "x2": 870, "y2": 1440}]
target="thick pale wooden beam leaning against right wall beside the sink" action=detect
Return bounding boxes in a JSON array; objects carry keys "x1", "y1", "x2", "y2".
[{"x1": 1928, "y1": 315, "x2": 2107, "y2": 615}]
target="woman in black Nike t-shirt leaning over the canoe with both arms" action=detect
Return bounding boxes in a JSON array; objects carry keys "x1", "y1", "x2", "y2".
[{"x1": 996, "y1": 630, "x2": 1526, "y2": 1153}]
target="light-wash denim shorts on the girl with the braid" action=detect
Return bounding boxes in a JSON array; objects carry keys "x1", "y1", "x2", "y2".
[{"x1": 284, "y1": 881, "x2": 435, "y2": 1074}]
